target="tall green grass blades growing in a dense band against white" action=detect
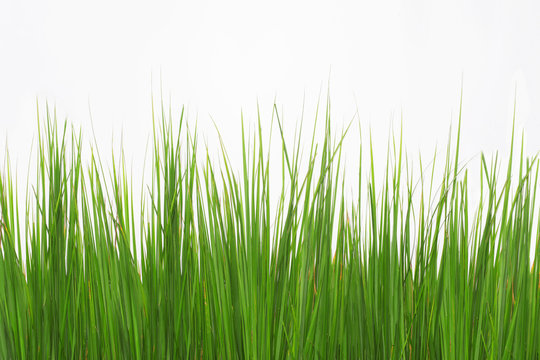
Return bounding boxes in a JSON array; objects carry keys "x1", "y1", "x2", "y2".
[{"x1": 0, "y1": 96, "x2": 540, "y2": 359}]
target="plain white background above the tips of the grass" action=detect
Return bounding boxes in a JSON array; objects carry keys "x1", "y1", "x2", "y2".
[{"x1": 0, "y1": 0, "x2": 540, "y2": 231}]
